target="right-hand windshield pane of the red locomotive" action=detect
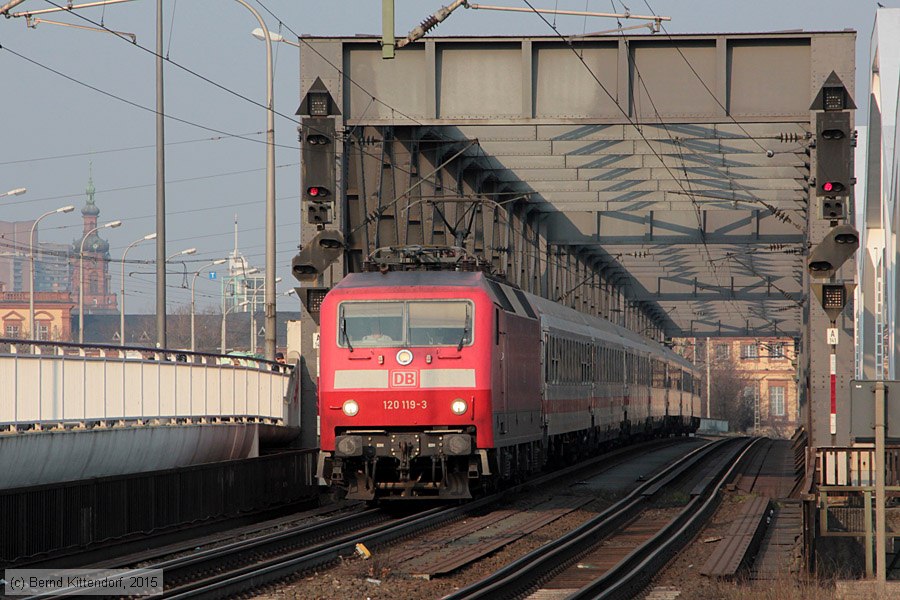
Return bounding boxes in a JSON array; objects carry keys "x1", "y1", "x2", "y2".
[{"x1": 409, "y1": 300, "x2": 474, "y2": 347}]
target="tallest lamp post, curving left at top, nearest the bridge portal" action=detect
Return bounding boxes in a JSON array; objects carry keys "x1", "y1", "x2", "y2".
[{"x1": 236, "y1": 0, "x2": 275, "y2": 360}]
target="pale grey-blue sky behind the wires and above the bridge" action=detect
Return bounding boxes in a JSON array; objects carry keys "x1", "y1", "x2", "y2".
[{"x1": 0, "y1": 0, "x2": 884, "y2": 313}]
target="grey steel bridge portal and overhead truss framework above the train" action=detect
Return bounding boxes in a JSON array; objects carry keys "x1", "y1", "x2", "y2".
[{"x1": 300, "y1": 31, "x2": 856, "y2": 445}]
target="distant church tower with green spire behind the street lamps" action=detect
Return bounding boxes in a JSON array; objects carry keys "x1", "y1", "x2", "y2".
[{"x1": 70, "y1": 174, "x2": 119, "y2": 315}]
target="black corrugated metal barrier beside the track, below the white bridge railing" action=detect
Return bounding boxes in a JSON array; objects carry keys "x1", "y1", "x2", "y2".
[{"x1": 0, "y1": 450, "x2": 317, "y2": 565}]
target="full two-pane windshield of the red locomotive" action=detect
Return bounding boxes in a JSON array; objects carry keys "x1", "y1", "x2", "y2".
[{"x1": 337, "y1": 300, "x2": 474, "y2": 348}]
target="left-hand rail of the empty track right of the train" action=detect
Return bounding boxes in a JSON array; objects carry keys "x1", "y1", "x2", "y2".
[{"x1": 442, "y1": 438, "x2": 737, "y2": 600}]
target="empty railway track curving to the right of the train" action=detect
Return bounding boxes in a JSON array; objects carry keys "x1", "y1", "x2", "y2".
[{"x1": 444, "y1": 439, "x2": 755, "y2": 600}]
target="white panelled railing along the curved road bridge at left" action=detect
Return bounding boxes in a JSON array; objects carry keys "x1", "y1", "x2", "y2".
[{"x1": 0, "y1": 338, "x2": 291, "y2": 431}]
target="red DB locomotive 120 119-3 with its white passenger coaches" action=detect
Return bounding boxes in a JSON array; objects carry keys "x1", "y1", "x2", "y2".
[{"x1": 317, "y1": 269, "x2": 700, "y2": 502}]
